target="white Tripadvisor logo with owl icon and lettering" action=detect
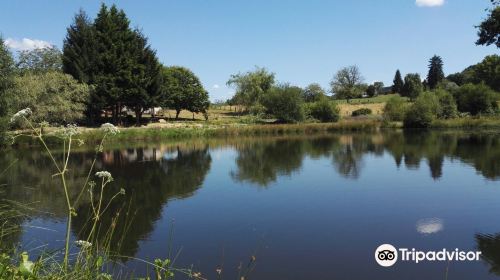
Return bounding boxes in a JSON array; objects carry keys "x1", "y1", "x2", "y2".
[{"x1": 375, "y1": 244, "x2": 481, "y2": 267}]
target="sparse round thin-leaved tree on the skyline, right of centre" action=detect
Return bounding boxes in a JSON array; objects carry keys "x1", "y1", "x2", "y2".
[{"x1": 330, "y1": 65, "x2": 364, "y2": 102}]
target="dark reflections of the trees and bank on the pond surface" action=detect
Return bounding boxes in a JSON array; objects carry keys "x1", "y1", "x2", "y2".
[{"x1": 0, "y1": 131, "x2": 500, "y2": 263}]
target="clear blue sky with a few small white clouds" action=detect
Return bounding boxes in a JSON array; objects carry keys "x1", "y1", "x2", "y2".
[{"x1": 0, "y1": 0, "x2": 500, "y2": 101}]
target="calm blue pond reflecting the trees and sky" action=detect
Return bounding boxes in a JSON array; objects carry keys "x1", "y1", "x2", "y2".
[{"x1": 0, "y1": 130, "x2": 500, "y2": 279}]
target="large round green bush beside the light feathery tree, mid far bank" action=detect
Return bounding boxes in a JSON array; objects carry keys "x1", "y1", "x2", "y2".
[{"x1": 261, "y1": 84, "x2": 304, "y2": 122}]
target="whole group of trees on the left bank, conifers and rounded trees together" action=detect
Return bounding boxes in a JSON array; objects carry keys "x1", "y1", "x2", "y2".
[{"x1": 0, "y1": 4, "x2": 209, "y2": 128}]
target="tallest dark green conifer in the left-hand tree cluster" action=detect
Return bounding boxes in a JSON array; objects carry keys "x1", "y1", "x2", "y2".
[{"x1": 94, "y1": 4, "x2": 137, "y2": 124}]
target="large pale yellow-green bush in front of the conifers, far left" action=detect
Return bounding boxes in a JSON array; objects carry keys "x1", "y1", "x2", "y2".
[{"x1": 7, "y1": 72, "x2": 91, "y2": 124}]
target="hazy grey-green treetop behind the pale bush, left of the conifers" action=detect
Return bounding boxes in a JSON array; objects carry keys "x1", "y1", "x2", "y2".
[{"x1": 16, "y1": 46, "x2": 62, "y2": 74}]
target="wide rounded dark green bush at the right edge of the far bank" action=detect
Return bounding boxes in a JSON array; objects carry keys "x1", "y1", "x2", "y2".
[{"x1": 454, "y1": 83, "x2": 498, "y2": 115}]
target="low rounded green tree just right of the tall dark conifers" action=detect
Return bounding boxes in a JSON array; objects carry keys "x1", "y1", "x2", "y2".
[{"x1": 161, "y1": 66, "x2": 209, "y2": 119}]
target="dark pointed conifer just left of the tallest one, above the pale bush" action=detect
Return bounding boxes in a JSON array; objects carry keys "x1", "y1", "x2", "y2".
[{"x1": 62, "y1": 10, "x2": 97, "y2": 83}]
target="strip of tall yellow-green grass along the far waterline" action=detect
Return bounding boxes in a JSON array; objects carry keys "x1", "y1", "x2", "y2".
[{"x1": 8, "y1": 117, "x2": 500, "y2": 145}]
